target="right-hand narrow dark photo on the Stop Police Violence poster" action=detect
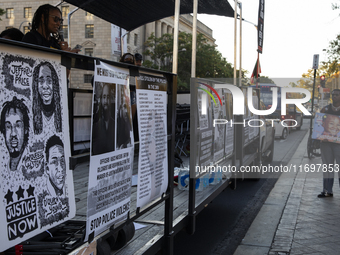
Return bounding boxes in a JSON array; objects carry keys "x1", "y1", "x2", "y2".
[{"x1": 117, "y1": 86, "x2": 132, "y2": 149}]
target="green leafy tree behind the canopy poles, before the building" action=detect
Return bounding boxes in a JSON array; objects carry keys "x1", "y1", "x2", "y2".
[{"x1": 143, "y1": 32, "x2": 235, "y2": 90}]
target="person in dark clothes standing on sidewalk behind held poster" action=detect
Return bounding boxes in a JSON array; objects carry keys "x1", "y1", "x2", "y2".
[{"x1": 318, "y1": 89, "x2": 340, "y2": 198}]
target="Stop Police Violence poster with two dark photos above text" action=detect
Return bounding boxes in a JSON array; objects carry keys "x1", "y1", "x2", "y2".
[{"x1": 86, "y1": 62, "x2": 134, "y2": 240}]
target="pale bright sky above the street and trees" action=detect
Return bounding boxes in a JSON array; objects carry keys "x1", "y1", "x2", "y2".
[{"x1": 198, "y1": 0, "x2": 340, "y2": 78}]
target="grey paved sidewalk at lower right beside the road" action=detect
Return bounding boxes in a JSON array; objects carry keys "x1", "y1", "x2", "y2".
[{"x1": 234, "y1": 132, "x2": 340, "y2": 255}]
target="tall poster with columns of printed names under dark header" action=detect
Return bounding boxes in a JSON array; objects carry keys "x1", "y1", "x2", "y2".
[{"x1": 136, "y1": 73, "x2": 168, "y2": 207}]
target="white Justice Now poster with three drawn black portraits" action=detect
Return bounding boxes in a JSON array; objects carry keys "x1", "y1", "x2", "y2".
[{"x1": 0, "y1": 45, "x2": 75, "y2": 251}]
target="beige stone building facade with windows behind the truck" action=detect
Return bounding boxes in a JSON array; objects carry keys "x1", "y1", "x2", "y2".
[{"x1": 0, "y1": 0, "x2": 215, "y2": 89}]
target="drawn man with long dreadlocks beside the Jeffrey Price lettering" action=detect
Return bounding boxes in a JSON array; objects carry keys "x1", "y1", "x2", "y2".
[{"x1": 32, "y1": 62, "x2": 62, "y2": 135}]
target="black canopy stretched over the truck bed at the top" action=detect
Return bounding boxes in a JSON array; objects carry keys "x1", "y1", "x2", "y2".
[{"x1": 65, "y1": 0, "x2": 234, "y2": 31}]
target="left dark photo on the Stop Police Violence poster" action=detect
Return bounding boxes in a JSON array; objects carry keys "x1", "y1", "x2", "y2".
[{"x1": 92, "y1": 82, "x2": 116, "y2": 155}]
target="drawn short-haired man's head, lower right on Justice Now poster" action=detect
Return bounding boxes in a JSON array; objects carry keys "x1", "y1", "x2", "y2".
[{"x1": 45, "y1": 135, "x2": 66, "y2": 197}]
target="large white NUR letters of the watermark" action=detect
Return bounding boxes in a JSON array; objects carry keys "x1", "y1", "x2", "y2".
[{"x1": 201, "y1": 84, "x2": 311, "y2": 116}]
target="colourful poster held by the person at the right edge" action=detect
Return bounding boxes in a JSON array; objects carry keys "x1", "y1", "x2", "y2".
[{"x1": 312, "y1": 112, "x2": 340, "y2": 143}]
